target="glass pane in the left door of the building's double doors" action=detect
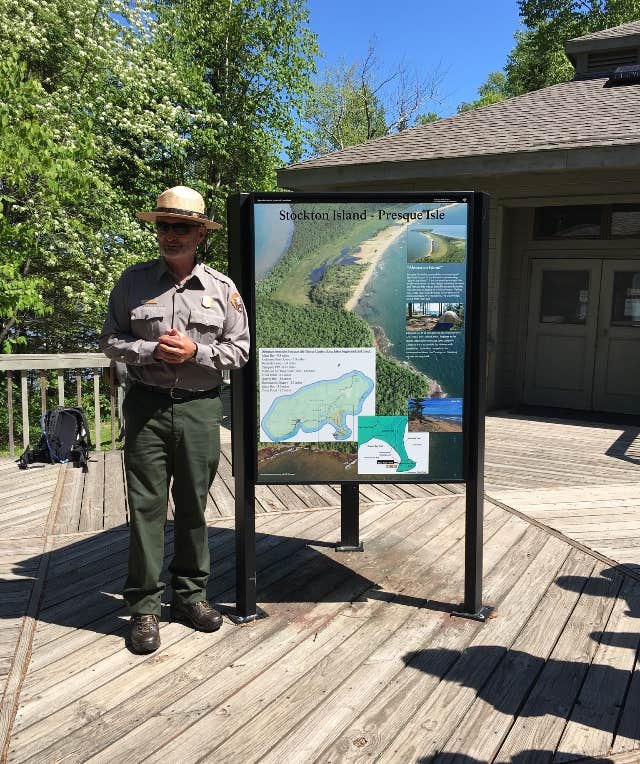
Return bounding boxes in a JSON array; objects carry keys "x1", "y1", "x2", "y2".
[{"x1": 540, "y1": 271, "x2": 589, "y2": 324}]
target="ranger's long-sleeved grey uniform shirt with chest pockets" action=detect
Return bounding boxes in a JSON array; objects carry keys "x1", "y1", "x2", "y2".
[{"x1": 100, "y1": 258, "x2": 249, "y2": 391}]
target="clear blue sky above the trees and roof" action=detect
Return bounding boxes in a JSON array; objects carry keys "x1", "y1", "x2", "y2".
[{"x1": 307, "y1": 0, "x2": 520, "y2": 117}]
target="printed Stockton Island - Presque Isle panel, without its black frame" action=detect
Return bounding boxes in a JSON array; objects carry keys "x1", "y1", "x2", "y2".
[{"x1": 253, "y1": 195, "x2": 468, "y2": 482}]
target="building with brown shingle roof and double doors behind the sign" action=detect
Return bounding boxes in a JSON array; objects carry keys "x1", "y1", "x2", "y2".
[{"x1": 278, "y1": 21, "x2": 640, "y2": 414}]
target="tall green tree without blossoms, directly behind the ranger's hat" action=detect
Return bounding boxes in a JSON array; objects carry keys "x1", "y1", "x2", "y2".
[{"x1": 157, "y1": 0, "x2": 318, "y2": 265}]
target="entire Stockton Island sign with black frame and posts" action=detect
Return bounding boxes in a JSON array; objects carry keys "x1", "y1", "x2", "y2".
[{"x1": 228, "y1": 192, "x2": 488, "y2": 622}]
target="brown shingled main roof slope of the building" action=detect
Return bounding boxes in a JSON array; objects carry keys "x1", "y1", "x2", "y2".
[{"x1": 285, "y1": 75, "x2": 640, "y2": 172}]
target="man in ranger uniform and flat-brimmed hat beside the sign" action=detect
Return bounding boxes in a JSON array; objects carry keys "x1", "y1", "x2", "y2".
[{"x1": 100, "y1": 186, "x2": 249, "y2": 653}]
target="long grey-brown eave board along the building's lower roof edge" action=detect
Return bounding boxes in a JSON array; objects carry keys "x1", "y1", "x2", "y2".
[{"x1": 278, "y1": 143, "x2": 640, "y2": 191}]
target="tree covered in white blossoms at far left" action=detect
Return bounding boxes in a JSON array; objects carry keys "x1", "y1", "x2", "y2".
[{"x1": 0, "y1": 0, "x2": 200, "y2": 352}]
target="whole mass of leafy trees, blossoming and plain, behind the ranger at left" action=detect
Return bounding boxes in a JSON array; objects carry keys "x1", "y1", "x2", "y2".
[{"x1": 0, "y1": 0, "x2": 315, "y2": 352}]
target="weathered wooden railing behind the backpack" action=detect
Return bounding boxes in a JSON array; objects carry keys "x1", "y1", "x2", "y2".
[{"x1": 0, "y1": 353, "x2": 123, "y2": 456}]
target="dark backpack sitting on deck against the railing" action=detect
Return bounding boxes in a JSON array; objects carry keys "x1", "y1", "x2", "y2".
[{"x1": 18, "y1": 406, "x2": 91, "y2": 472}]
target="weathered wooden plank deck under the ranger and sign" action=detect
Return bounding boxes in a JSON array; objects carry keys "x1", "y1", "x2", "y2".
[{"x1": 0, "y1": 416, "x2": 640, "y2": 764}]
